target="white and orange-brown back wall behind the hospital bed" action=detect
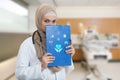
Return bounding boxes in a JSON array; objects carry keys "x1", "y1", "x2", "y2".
[{"x1": 56, "y1": 6, "x2": 120, "y2": 34}]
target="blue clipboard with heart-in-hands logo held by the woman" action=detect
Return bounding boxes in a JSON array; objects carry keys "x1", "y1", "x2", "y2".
[{"x1": 46, "y1": 25, "x2": 71, "y2": 66}]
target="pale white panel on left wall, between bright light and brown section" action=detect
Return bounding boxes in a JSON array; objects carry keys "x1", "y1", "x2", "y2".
[{"x1": 0, "y1": 8, "x2": 28, "y2": 33}]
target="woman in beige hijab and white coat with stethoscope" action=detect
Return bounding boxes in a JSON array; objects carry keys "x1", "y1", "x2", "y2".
[{"x1": 16, "y1": 4, "x2": 75, "y2": 80}]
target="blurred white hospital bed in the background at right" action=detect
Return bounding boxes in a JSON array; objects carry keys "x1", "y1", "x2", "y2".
[{"x1": 82, "y1": 27, "x2": 112, "y2": 80}]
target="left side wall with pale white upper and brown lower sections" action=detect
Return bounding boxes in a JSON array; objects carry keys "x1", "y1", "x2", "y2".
[{"x1": 0, "y1": 2, "x2": 29, "y2": 62}]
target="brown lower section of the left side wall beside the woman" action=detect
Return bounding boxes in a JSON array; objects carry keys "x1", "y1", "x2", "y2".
[{"x1": 0, "y1": 33, "x2": 29, "y2": 62}]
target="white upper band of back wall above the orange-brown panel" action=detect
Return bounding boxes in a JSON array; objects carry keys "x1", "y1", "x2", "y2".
[{"x1": 57, "y1": 7, "x2": 120, "y2": 18}]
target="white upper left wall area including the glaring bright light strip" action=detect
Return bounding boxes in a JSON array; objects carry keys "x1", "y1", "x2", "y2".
[{"x1": 0, "y1": 0, "x2": 28, "y2": 33}]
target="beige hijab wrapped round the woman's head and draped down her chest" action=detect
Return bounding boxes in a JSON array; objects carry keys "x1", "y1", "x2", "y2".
[{"x1": 33, "y1": 4, "x2": 62, "y2": 72}]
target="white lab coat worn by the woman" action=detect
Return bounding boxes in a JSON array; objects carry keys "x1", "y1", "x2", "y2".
[{"x1": 16, "y1": 37, "x2": 74, "y2": 80}]
